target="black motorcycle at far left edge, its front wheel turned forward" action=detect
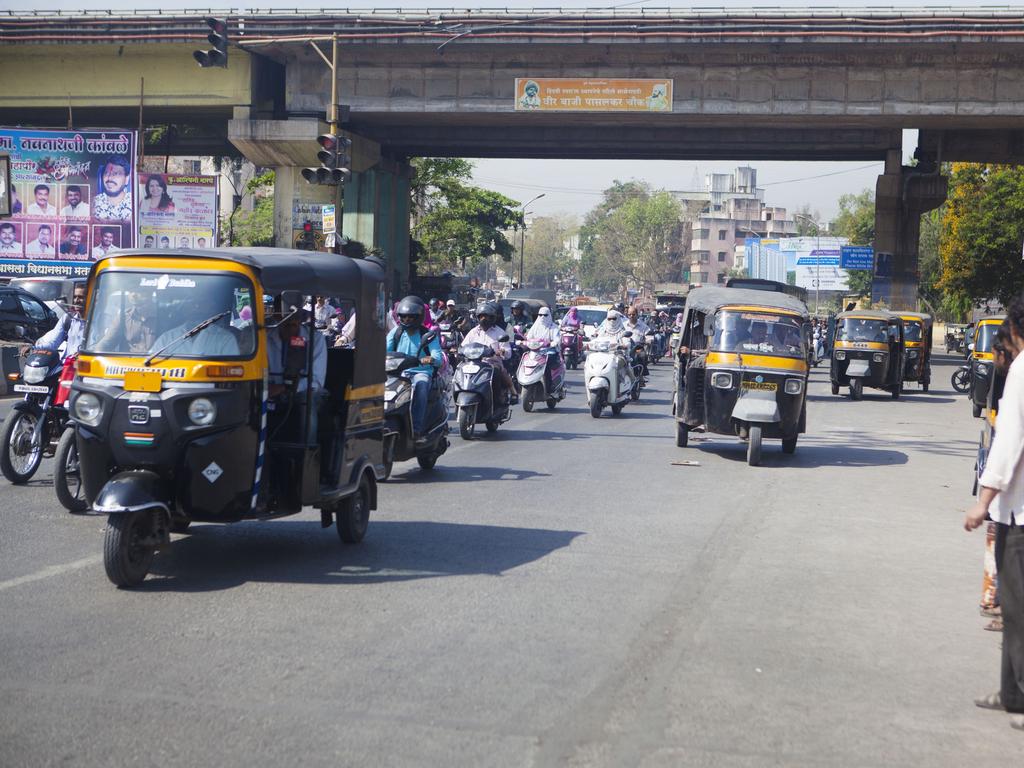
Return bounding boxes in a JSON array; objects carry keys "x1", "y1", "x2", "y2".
[{"x1": 0, "y1": 349, "x2": 77, "y2": 485}]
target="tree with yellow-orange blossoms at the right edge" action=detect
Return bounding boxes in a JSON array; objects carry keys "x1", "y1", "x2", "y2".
[{"x1": 938, "y1": 163, "x2": 1024, "y2": 308}]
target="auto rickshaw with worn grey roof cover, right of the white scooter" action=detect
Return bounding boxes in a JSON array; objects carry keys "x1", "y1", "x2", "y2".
[{"x1": 673, "y1": 288, "x2": 810, "y2": 465}]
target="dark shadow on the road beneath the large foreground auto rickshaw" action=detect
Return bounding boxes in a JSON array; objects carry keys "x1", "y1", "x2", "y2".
[{"x1": 138, "y1": 516, "x2": 583, "y2": 592}]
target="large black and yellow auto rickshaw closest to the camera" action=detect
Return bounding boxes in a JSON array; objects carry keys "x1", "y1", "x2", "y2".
[{"x1": 70, "y1": 248, "x2": 385, "y2": 586}]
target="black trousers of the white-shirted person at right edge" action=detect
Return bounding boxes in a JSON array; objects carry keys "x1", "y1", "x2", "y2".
[{"x1": 995, "y1": 523, "x2": 1024, "y2": 713}]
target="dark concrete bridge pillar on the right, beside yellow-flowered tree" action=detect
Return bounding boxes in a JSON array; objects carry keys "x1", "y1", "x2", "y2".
[{"x1": 871, "y1": 150, "x2": 948, "y2": 311}]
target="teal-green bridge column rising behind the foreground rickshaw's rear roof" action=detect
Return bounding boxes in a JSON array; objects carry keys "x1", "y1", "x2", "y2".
[{"x1": 342, "y1": 160, "x2": 413, "y2": 297}]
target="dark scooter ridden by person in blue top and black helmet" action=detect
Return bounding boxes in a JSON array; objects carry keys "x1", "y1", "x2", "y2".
[{"x1": 382, "y1": 348, "x2": 452, "y2": 480}]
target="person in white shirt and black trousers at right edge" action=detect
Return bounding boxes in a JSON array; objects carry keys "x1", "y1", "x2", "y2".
[{"x1": 964, "y1": 299, "x2": 1024, "y2": 730}]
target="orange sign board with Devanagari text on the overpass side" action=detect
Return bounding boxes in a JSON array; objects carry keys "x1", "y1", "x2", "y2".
[{"x1": 515, "y1": 78, "x2": 672, "y2": 112}]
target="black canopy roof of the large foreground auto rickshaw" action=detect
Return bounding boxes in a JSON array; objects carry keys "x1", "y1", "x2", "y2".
[{"x1": 90, "y1": 247, "x2": 384, "y2": 297}]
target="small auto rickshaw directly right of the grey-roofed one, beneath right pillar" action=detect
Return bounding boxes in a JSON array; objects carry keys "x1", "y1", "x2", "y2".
[{"x1": 830, "y1": 309, "x2": 906, "y2": 400}]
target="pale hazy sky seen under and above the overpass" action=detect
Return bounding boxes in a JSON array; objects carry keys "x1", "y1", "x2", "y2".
[{"x1": 25, "y1": 0, "x2": 1007, "y2": 219}]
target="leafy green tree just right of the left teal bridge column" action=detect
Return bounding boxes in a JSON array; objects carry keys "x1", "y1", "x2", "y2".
[{"x1": 410, "y1": 158, "x2": 522, "y2": 273}]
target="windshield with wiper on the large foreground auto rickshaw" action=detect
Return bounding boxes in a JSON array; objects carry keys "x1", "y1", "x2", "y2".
[{"x1": 84, "y1": 271, "x2": 256, "y2": 358}]
